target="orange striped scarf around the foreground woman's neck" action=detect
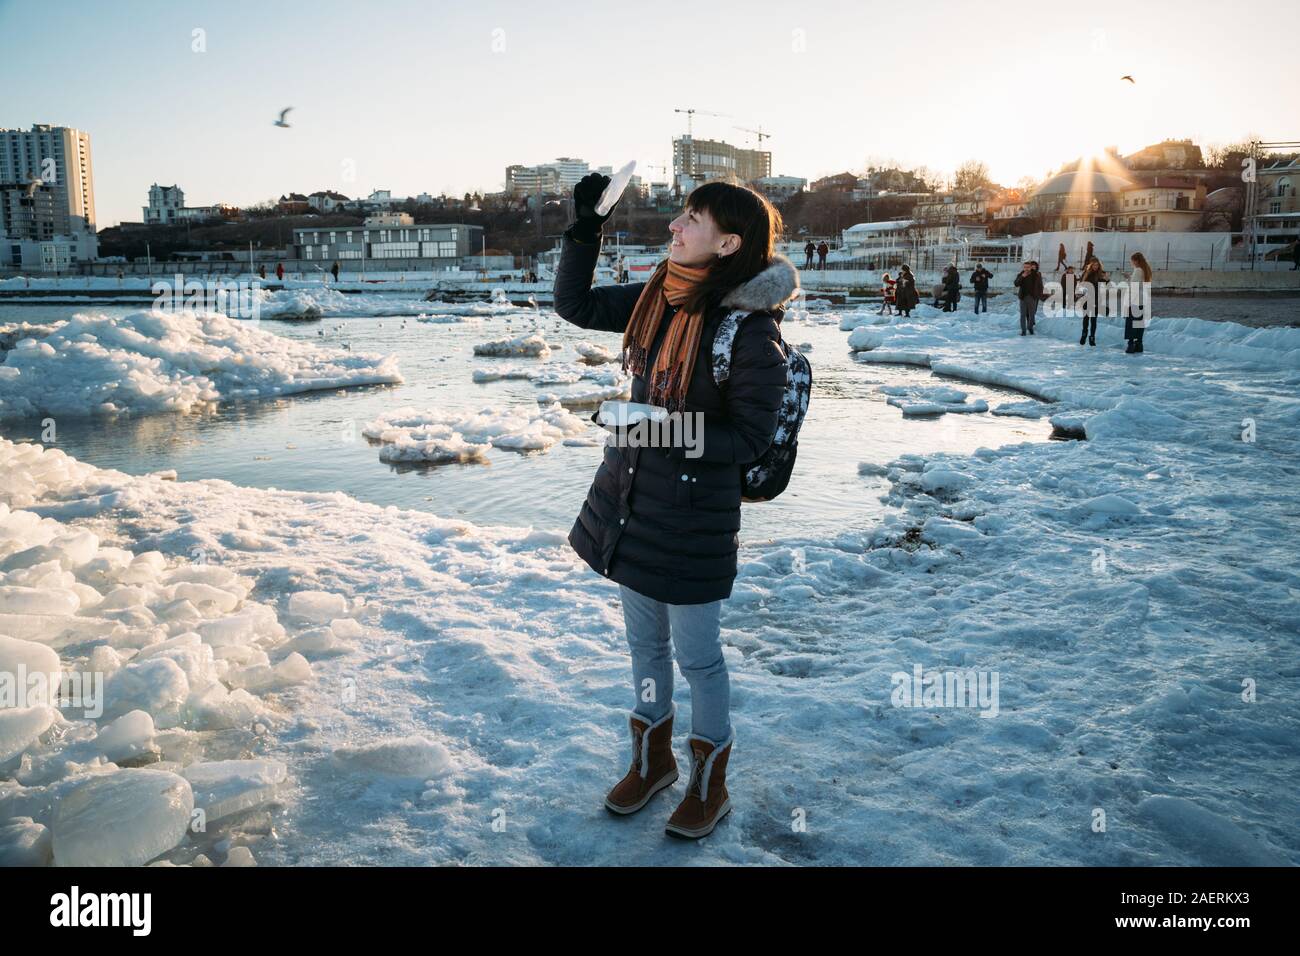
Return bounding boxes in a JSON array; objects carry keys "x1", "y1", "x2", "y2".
[{"x1": 623, "y1": 259, "x2": 709, "y2": 411}]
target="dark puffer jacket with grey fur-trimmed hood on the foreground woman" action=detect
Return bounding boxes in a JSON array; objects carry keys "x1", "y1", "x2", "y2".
[{"x1": 555, "y1": 234, "x2": 798, "y2": 605}]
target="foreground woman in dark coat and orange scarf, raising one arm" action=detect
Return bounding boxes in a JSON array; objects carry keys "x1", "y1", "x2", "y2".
[{"x1": 555, "y1": 173, "x2": 798, "y2": 838}]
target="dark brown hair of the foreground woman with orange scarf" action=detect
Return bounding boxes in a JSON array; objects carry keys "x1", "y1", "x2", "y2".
[{"x1": 664, "y1": 182, "x2": 785, "y2": 312}]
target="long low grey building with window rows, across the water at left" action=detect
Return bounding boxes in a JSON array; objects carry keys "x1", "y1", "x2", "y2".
[{"x1": 293, "y1": 221, "x2": 484, "y2": 269}]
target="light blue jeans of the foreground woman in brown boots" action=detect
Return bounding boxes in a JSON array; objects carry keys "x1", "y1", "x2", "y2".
[{"x1": 619, "y1": 584, "x2": 731, "y2": 744}]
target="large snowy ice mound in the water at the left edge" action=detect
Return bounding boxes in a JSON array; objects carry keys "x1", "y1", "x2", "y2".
[{"x1": 0, "y1": 311, "x2": 402, "y2": 420}]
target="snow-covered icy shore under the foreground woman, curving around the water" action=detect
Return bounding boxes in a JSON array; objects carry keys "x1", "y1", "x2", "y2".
[{"x1": 0, "y1": 300, "x2": 1300, "y2": 865}]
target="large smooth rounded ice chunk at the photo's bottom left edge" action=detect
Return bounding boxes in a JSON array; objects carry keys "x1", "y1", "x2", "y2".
[{"x1": 51, "y1": 770, "x2": 194, "y2": 866}]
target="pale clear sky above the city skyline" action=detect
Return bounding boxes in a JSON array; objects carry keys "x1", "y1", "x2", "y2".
[{"x1": 0, "y1": 0, "x2": 1300, "y2": 228}]
